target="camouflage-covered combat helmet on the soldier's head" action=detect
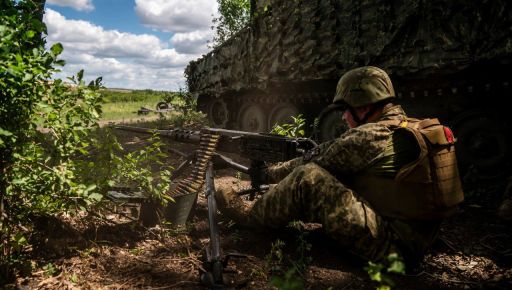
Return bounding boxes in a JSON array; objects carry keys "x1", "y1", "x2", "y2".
[{"x1": 332, "y1": 66, "x2": 395, "y2": 108}]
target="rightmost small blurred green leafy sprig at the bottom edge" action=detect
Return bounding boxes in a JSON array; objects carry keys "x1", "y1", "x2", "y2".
[{"x1": 364, "y1": 253, "x2": 405, "y2": 290}]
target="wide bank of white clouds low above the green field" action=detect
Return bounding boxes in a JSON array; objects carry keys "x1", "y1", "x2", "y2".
[{"x1": 44, "y1": 9, "x2": 202, "y2": 90}]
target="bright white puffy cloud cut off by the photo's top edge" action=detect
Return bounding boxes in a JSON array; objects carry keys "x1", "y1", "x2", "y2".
[{"x1": 135, "y1": 0, "x2": 218, "y2": 33}]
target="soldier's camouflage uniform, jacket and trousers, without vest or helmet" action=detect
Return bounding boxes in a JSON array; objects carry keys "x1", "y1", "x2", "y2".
[{"x1": 218, "y1": 106, "x2": 439, "y2": 260}]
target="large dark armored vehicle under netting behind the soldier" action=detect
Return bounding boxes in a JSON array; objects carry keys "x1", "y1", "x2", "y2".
[{"x1": 185, "y1": 0, "x2": 512, "y2": 177}]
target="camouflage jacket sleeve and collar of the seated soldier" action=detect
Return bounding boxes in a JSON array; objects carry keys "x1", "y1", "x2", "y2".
[{"x1": 268, "y1": 105, "x2": 406, "y2": 182}]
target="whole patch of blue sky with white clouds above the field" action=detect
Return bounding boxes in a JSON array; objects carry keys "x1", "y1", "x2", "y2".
[{"x1": 44, "y1": 0, "x2": 217, "y2": 90}]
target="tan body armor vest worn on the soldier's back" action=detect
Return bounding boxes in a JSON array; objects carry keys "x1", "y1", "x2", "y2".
[{"x1": 353, "y1": 118, "x2": 464, "y2": 220}]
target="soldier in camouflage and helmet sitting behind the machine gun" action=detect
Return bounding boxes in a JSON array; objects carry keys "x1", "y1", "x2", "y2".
[{"x1": 216, "y1": 66, "x2": 463, "y2": 264}]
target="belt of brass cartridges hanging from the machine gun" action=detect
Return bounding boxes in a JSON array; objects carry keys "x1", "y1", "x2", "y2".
[{"x1": 170, "y1": 132, "x2": 220, "y2": 196}]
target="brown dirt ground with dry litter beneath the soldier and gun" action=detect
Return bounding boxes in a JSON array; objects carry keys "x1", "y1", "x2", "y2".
[{"x1": 7, "y1": 134, "x2": 512, "y2": 289}]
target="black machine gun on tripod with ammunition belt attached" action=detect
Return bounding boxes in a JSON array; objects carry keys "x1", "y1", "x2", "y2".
[{"x1": 115, "y1": 126, "x2": 317, "y2": 289}]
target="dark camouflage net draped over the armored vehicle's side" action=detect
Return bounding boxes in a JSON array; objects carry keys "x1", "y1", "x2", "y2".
[{"x1": 185, "y1": 0, "x2": 512, "y2": 96}]
